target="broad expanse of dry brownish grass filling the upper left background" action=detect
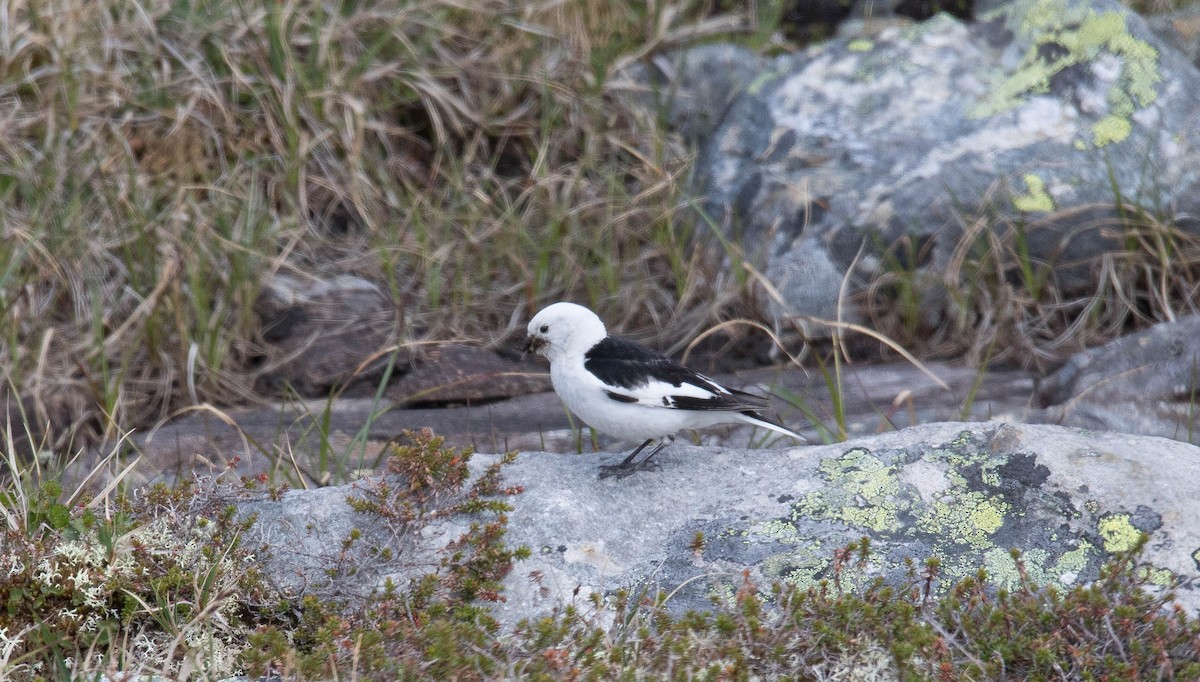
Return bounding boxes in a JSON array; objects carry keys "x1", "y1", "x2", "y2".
[{"x1": 0, "y1": 0, "x2": 758, "y2": 458}]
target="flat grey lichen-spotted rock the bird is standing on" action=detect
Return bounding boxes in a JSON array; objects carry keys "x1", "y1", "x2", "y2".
[{"x1": 244, "y1": 421, "x2": 1200, "y2": 624}]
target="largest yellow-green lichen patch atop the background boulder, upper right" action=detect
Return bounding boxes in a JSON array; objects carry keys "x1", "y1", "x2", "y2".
[{"x1": 971, "y1": 0, "x2": 1163, "y2": 146}]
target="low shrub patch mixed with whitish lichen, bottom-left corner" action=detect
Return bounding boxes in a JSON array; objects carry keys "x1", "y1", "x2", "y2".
[{"x1": 0, "y1": 473, "x2": 268, "y2": 678}]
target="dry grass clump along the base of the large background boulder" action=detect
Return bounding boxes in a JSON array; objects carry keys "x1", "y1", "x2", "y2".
[{"x1": 864, "y1": 194, "x2": 1200, "y2": 372}]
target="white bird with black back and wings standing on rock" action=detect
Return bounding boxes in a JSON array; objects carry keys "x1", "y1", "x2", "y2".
[{"x1": 524, "y1": 301, "x2": 804, "y2": 479}]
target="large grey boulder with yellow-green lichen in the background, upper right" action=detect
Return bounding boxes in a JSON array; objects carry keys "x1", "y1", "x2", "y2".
[{"x1": 697, "y1": 0, "x2": 1200, "y2": 333}]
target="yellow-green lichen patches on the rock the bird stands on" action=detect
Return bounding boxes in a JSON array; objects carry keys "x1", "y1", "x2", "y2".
[{"x1": 768, "y1": 432, "x2": 1171, "y2": 602}]
